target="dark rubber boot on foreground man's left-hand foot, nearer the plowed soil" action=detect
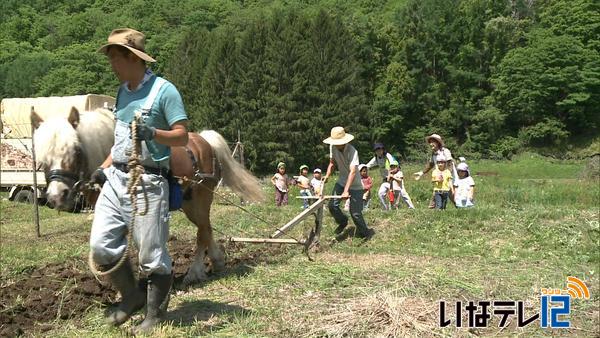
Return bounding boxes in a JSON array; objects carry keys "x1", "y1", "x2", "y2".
[{"x1": 107, "y1": 260, "x2": 146, "y2": 326}]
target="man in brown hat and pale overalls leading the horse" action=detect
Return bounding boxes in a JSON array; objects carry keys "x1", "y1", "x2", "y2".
[{"x1": 90, "y1": 28, "x2": 188, "y2": 333}]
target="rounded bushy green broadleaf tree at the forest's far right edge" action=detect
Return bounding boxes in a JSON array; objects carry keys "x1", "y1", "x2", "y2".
[{"x1": 492, "y1": 30, "x2": 600, "y2": 140}]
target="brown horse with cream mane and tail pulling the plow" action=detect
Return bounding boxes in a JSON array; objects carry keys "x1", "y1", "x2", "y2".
[{"x1": 31, "y1": 107, "x2": 264, "y2": 286}]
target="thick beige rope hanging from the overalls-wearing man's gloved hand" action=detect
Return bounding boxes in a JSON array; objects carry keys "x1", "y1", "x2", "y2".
[{"x1": 88, "y1": 116, "x2": 148, "y2": 276}]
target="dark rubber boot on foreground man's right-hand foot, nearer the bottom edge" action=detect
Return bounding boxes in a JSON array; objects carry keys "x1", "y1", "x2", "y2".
[{"x1": 134, "y1": 274, "x2": 173, "y2": 334}]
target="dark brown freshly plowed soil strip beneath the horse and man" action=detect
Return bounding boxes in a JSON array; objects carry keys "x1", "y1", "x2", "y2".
[{"x1": 0, "y1": 237, "x2": 285, "y2": 337}]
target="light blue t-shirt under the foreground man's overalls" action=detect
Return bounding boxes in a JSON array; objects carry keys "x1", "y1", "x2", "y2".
[{"x1": 113, "y1": 75, "x2": 188, "y2": 166}]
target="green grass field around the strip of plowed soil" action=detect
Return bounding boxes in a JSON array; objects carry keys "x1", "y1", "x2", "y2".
[{"x1": 0, "y1": 155, "x2": 600, "y2": 337}]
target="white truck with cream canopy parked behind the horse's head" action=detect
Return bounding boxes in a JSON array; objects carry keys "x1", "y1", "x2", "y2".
[{"x1": 0, "y1": 94, "x2": 115, "y2": 203}]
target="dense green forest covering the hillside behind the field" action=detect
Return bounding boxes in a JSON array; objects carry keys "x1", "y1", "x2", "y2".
[{"x1": 0, "y1": 0, "x2": 600, "y2": 173}]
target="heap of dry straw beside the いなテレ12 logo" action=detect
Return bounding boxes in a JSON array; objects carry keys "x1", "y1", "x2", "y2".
[{"x1": 305, "y1": 292, "x2": 437, "y2": 337}]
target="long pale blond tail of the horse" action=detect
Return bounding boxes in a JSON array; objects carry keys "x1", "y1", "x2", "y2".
[{"x1": 200, "y1": 130, "x2": 265, "y2": 202}]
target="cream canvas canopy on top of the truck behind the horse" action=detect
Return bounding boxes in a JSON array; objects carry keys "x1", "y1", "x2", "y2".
[{"x1": 0, "y1": 94, "x2": 115, "y2": 138}]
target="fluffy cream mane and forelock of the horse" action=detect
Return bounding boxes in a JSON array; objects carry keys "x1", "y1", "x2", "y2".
[{"x1": 34, "y1": 108, "x2": 114, "y2": 172}]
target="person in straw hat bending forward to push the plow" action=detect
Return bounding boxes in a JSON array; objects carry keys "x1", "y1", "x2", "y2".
[{"x1": 323, "y1": 127, "x2": 375, "y2": 240}]
